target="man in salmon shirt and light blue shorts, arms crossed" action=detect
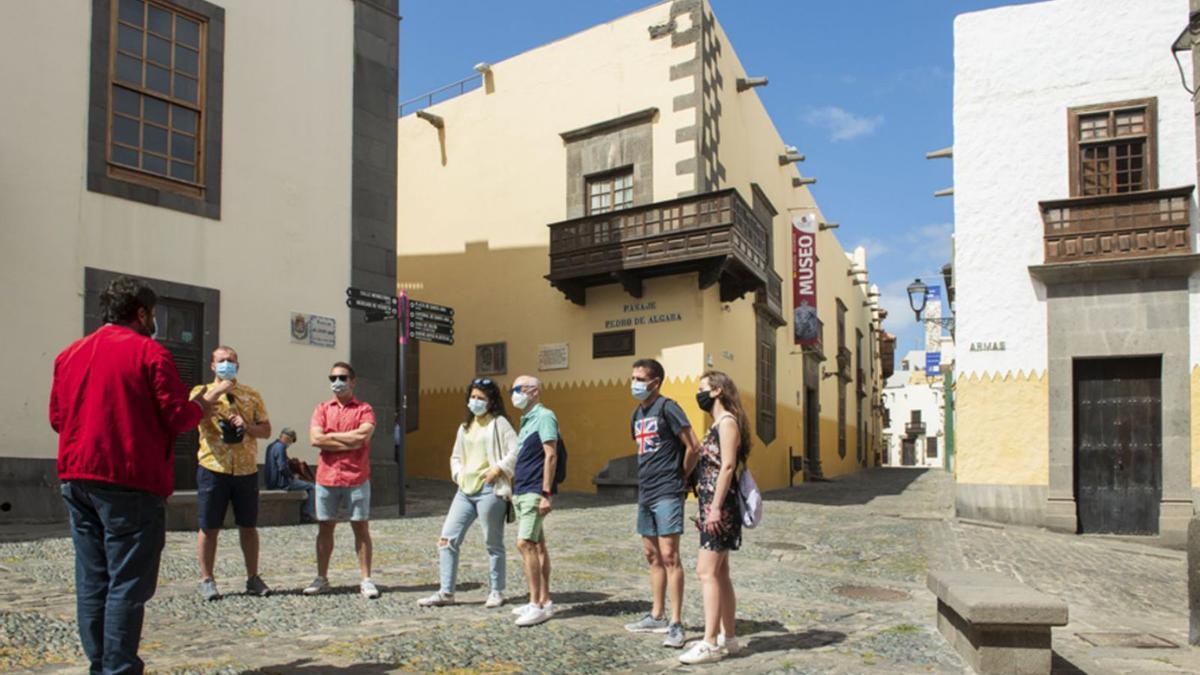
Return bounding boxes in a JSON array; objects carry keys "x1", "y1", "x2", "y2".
[{"x1": 304, "y1": 362, "x2": 379, "y2": 598}]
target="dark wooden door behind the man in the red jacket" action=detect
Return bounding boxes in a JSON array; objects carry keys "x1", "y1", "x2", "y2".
[{"x1": 155, "y1": 298, "x2": 205, "y2": 490}]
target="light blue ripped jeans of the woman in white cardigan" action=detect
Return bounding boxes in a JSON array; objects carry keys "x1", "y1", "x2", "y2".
[{"x1": 438, "y1": 485, "x2": 506, "y2": 593}]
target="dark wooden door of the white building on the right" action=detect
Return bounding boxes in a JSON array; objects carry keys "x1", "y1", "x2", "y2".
[{"x1": 1074, "y1": 357, "x2": 1163, "y2": 534}]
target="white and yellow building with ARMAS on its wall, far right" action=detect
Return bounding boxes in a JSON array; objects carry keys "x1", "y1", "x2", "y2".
[{"x1": 954, "y1": 0, "x2": 1200, "y2": 543}]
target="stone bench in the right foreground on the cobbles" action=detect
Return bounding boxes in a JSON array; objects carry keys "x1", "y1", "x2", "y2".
[{"x1": 926, "y1": 572, "x2": 1067, "y2": 675}]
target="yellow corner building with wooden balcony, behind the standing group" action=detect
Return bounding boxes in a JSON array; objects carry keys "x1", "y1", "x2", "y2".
[{"x1": 397, "y1": 0, "x2": 882, "y2": 490}]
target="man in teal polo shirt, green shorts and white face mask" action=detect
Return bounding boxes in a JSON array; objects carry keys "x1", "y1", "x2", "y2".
[{"x1": 512, "y1": 375, "x2": 558, "y2": 626}]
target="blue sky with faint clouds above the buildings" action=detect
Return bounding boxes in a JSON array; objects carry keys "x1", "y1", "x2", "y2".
[{"x1": 400, "y1": 0, "x2": 1046, "y2": 354}]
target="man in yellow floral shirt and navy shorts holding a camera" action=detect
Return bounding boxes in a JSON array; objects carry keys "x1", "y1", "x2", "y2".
[{"x1": 192, "y1": 346, "x2": 271, "y2": 601}]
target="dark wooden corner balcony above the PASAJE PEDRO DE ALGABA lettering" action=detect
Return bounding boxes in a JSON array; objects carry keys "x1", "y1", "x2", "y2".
[{"x1": 546, "y1": 189, "x2": 782, "y2": 307}]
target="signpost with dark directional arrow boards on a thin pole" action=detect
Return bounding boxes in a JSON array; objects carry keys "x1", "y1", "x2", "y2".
[{"x1": 346, "y1": 286, "x2": 454, "y2": 515}]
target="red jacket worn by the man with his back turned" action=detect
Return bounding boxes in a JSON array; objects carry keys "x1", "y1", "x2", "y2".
[{"x1": 50, "y1": 324, "x2": 200, "y2": 498}]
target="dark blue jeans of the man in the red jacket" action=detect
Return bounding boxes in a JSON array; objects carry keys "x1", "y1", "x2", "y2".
[{"x1": 62, "y1": 480, "x2": 167, "y2": 674}]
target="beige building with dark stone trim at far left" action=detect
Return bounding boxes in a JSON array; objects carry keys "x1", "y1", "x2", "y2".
[{"x1": 0, "y1": 0, "x2": 398, "y2": 522}]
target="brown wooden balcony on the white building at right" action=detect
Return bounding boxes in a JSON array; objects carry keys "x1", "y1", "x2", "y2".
[{"x1": 1039, "y1": 185, "x2": 1193, "y2": 264}]
